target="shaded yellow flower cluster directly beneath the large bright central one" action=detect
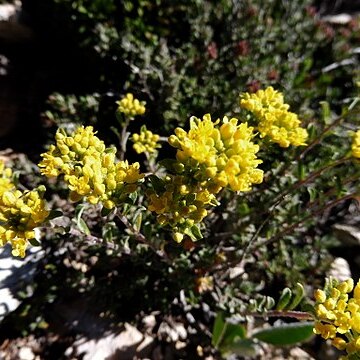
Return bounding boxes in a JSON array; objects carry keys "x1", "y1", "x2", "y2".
[{"x1": 147, "y1": 175, "x2": 218, "y2": 242}]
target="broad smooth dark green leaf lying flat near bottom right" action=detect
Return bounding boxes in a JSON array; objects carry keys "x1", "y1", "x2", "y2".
[{"x1": 252, "y1": 321, "x2": 314, "y2": 346}]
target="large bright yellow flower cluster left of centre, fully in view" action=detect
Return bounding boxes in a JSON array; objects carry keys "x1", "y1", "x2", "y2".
[{"x1": 39, "y1": 126, "x2": 144, "y2": 209}]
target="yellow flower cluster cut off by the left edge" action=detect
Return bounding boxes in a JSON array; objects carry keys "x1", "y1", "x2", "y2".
[{"x1": 0, "y1": 161, "x2": 49, "y2": 257}]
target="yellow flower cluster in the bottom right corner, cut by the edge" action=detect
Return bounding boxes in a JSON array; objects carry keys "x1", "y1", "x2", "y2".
[{"x1": 314, "y1": 279, "x2": 360, "y2": 359}]
